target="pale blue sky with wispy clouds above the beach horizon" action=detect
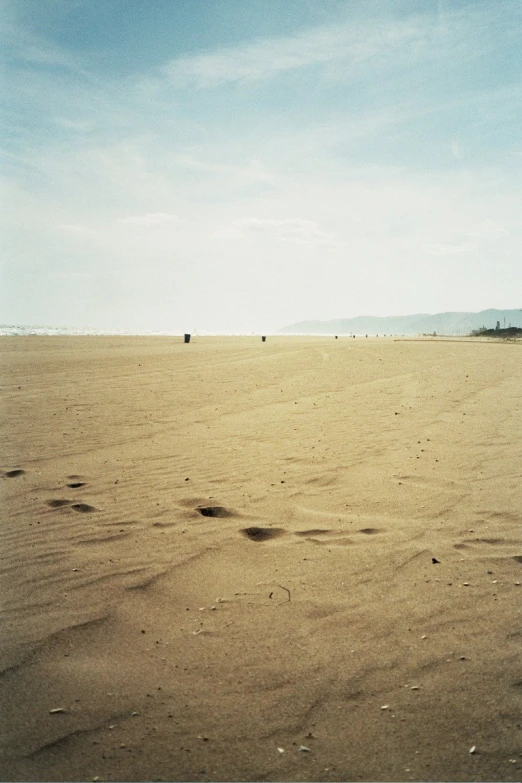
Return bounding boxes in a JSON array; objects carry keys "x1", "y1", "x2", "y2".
[{"x1": 0, "y1": 0, "x2": 522, "y2": 333}]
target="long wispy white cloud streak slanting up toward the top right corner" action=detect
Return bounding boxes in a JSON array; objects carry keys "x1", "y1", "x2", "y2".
[{"x1": 162, "y1": 0, "x2": 516, "y2": 89}]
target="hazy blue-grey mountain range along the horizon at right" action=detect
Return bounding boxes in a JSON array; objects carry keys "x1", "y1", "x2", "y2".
[{"x1": 279, "y1": 309, "x2": 522, "y2": 335}]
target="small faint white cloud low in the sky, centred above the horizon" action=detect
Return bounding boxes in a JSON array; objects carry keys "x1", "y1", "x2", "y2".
[{"x1": 215, "y1": 218, "x2": 342, "y2": 248}]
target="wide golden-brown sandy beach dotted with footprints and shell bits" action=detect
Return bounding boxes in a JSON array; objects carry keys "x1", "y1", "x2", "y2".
[{"x1": 0, "y1": 337, "x2": 522, "y2": 781}]
